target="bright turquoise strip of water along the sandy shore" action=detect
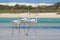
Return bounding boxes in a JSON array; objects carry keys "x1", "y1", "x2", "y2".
[{"x1": 0, "y1": 18, "x2": 60, "y2": 23}]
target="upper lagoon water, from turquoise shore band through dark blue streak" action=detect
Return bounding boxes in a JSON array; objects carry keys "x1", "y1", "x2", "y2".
[{"x1": 0, "y1": 18, "x2": 60, "y2": 29}]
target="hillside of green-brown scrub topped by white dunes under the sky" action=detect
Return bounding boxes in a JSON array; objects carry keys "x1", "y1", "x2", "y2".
[{"x1": 0, "y1": 2, "x2": 60, "y2": 13}]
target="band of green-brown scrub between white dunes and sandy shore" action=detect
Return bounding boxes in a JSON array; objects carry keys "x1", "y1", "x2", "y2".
[{"x1": 0, "y1": 2, "x2": 60, "y2": 14}]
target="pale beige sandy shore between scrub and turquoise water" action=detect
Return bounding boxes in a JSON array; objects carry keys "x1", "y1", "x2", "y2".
[{"x1": 0, "y1": 13, "x2": 60, "y2": 18}]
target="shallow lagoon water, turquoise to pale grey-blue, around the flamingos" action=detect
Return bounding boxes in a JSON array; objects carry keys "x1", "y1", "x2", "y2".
[{"x1": 0, "y1": 18, "x2": 60, "y2": 38}]
